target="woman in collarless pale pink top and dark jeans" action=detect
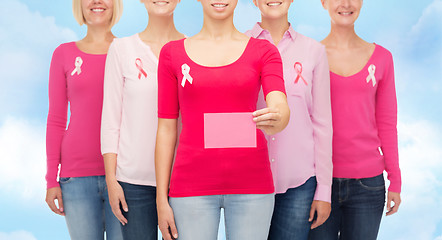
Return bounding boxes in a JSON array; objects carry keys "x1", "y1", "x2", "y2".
[{"x1": 101, "y1": 0, "x2": 184, "y2": 240}]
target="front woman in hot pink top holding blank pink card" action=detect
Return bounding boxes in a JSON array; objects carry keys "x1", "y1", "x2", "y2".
[{"x1": 155, "y1": 0, "x2": 289, "y2": 240}]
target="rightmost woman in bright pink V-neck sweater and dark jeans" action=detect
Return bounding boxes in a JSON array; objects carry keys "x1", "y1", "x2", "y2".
[{"x1": 310, "y1": 0, "x2": 401, "y2": 240}]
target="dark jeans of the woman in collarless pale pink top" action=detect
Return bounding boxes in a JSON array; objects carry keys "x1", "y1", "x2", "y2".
[{"x1": 119, "y1": 182, "x2": 158, "y2": 240}]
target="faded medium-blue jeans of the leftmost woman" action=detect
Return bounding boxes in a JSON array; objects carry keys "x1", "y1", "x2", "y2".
[{"x1": 60, "y1": 176, "x2": 123, "y2": 240}]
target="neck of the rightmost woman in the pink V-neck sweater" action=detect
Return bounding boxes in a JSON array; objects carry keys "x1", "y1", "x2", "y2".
[{"x1": 325, "y1": 23, "x2": 362, "y2": 48}]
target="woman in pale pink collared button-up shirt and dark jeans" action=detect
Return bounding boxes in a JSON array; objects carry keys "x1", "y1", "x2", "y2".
[{"x1": 246, "y1": 0, "x2": 332, "y2": 240}]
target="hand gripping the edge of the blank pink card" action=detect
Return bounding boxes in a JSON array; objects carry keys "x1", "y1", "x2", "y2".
[{"x1": 253, "y1": 108, "x2": 281, "y2": 135}]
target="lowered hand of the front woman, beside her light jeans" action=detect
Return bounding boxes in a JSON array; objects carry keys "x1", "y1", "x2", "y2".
[{"x1": 157, "y1": 202, "x2": 178, "y2": 240}]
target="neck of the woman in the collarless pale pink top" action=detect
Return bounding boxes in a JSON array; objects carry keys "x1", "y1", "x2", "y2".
[{"x1": 140, "y1": 15, "x2": 181, "y2": 42}]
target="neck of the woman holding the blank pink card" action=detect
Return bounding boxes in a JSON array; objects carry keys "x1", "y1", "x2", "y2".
[{"x1": 198, "y1": 15, "x2": 239, "y2": 40}]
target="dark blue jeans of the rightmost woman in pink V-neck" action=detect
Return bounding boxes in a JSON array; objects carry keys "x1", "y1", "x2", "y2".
[{"x1": 309, "y1": 174, "x2": 385, "y2": 240}]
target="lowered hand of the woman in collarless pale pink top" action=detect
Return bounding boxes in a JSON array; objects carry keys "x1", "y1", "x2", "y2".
[{"x1": 106, "y1": 179, "x2": 129, "y2": 226}]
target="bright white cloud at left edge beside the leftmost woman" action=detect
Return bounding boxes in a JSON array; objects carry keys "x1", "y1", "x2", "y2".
[{"x1": 0, "y1": 117, "x2": 46, "y2": 204}]
